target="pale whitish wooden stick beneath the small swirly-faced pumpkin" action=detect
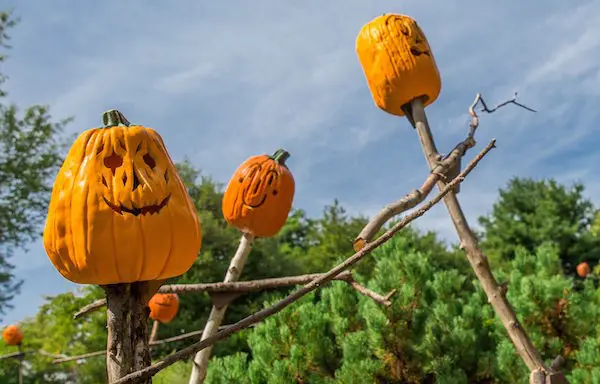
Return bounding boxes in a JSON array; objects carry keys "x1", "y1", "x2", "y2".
[{"x1": 189, "y1": 233, "x2": 254, "y2": 384}]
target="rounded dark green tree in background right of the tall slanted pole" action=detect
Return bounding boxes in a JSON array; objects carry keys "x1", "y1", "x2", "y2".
[{"x1": 479, "y1": 178, "x2": 600, "y2": 274}]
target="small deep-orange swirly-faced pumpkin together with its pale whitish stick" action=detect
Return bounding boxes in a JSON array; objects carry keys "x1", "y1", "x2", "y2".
[{"x1": 189, "y1": 149, "x2": 295, "y2": 384}]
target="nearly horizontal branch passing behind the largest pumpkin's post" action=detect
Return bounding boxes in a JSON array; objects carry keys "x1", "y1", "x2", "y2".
[{"x1": 73, "y1": 272, "x2": 386, "y2": 319}]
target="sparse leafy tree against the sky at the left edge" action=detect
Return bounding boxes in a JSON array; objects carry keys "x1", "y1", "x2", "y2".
[{"x1": 0, "y1": 12, "x2": 68, "y2": 313}]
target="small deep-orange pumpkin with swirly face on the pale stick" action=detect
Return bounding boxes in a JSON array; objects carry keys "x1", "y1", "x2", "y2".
[{"x1": 222, "y1": 149, "x2": 295, "y2": 237}]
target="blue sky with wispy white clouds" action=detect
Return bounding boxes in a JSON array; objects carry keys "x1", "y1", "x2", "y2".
[{"x1": 2, "y1": 0, "x2": 600, "y2": 323}]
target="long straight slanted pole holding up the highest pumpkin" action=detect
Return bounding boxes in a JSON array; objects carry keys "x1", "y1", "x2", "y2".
[{"x1": 411, "y1": 97, "x2": 548, "y2": 380}]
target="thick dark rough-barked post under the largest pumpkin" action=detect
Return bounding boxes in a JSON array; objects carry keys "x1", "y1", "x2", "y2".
[{"x1": 104, "y1": 282, "x2": 152, "y2": 384}]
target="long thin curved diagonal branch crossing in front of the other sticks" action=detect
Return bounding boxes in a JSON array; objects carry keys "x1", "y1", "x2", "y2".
[{"x1": 113, "y1": 140, "x2": 495, "y2": 384}]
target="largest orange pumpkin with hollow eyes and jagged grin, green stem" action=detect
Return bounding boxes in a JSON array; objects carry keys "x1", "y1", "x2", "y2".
[{"x1": 44, "y1": 110, "x2": 202, "y2": 285}]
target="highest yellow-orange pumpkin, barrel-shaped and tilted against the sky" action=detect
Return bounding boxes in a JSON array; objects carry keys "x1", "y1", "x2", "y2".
[{"x1": 356, "y1": 14, "x2": 442, "y2": 116}]
